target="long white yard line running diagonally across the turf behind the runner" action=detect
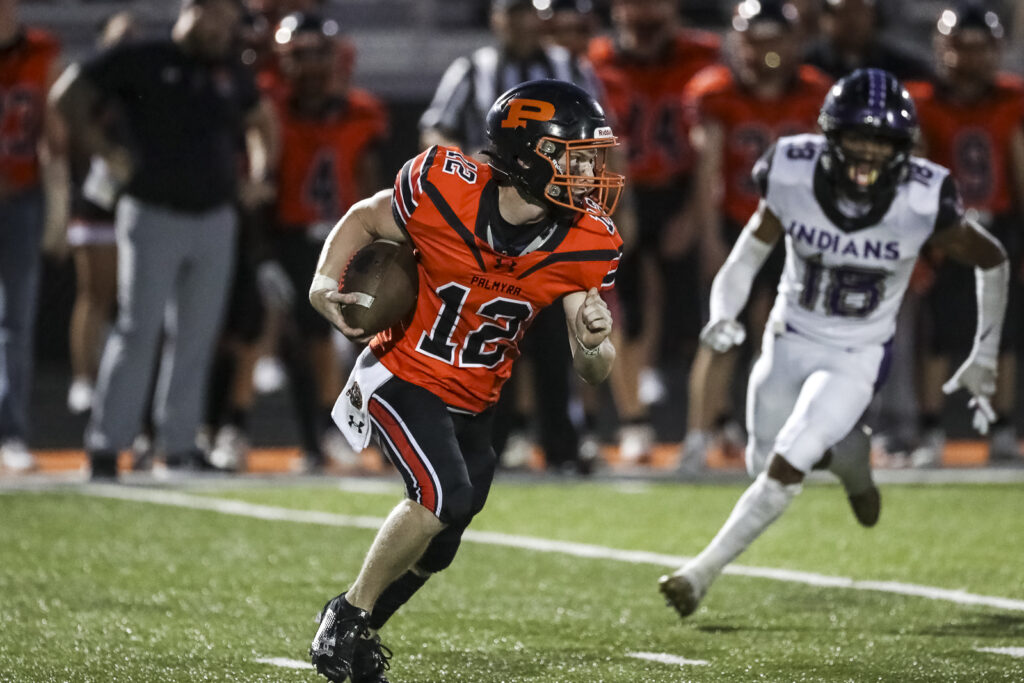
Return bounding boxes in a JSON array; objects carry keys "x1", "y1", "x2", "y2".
[{"x1": 79, "y1": 484, "x2": 1024, "y2": 611}]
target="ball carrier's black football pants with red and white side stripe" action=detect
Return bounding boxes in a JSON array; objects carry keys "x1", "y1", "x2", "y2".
[{"x1": 369, "y1": 377, "x2": 498, "y2": 526}]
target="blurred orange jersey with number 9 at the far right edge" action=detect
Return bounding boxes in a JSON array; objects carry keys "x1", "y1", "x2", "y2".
[{"x1": 907, "y1": 75, "x2": 1024, "y2": 214}]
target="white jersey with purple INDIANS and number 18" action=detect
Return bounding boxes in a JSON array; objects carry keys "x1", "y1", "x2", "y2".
[{"x1": 764, "y1": 135, "x2": 954, "y2": 348}]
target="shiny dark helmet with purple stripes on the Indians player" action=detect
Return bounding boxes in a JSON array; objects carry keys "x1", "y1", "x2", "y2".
[{"x1": 818, "y1": 69, "x2": 919, "y2": 200}]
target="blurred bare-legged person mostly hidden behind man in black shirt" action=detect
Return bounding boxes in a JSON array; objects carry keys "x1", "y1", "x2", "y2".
[{"x1": 68, "y1": 11, "x2": 139, "y2": 415}]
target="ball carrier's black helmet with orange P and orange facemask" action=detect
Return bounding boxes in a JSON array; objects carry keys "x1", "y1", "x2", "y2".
[{"x1": 484, "y1": 80, "x2": 625, "y2": 216}]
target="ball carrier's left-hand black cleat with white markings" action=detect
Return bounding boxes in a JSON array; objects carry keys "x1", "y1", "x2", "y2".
[{"x1": 309, "y1": 593, "x2": 374, "y2": 683}]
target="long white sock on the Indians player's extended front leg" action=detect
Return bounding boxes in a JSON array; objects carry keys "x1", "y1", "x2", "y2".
[{"x1": 682, "y1": 472, "x2": 803, "y2": 590}]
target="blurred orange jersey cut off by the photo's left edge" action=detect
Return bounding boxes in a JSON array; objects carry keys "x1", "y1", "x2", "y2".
[{"x1": 0, "y1": 29, "x2": 60, "y2": 190}]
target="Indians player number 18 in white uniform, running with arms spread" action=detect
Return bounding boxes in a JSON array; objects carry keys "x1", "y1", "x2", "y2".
[{"x1": 659, "y1": 69, "x2": 1010, "y2": 616}]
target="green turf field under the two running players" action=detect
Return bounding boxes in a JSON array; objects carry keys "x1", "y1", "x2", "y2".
[{"x1": 0, "y1": 482, "x2": 1024, "y2": 683}]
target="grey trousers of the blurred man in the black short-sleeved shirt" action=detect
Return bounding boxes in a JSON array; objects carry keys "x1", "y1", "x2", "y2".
[{"x1": 85, "y1": 197, "x2": 238, "y2": 453}]
